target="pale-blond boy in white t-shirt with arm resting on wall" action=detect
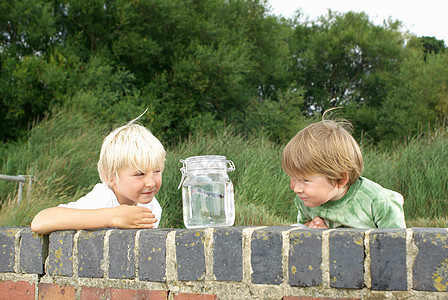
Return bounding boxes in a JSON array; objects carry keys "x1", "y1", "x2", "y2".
[{"x1": 31, "y1": 118, "x2": 165, "y2": 234}]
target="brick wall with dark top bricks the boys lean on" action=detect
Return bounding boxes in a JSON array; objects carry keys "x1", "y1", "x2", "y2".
[{"x1": 0, "y1": 227, "x2": 448, "y2": 300}]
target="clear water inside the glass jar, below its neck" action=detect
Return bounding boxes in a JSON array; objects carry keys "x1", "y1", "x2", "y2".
[{"x1": 182, "y1": 182, "x2": 235, "y2": 228}]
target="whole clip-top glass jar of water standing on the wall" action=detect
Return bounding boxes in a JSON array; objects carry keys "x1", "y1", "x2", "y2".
[{"x1": 179, "y1": 155, "x2": 235, "y2": 228}]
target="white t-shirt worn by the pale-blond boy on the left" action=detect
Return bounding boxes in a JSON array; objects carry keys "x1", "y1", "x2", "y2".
[{"x1": 58, "y1": 182, "x2": 162, "y2": 228}]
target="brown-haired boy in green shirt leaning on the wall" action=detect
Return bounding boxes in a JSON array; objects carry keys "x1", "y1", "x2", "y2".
[{"x1": 282, "y1": 120, "x2": 406, "y2": 229}]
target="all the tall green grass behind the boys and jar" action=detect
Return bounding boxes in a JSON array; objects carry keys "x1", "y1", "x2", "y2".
[{"x1": 0, "y1": 112, "x2": 448, "y2": 228}]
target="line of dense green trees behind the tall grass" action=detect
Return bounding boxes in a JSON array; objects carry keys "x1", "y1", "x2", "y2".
[{"x1": 0, "y1": 0, "x2": 448, "y2": 145}]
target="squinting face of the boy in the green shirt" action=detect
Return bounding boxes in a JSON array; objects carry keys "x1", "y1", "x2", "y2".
[{"x1": 291, "y1": 175, "x2": 347, "y2": 207}]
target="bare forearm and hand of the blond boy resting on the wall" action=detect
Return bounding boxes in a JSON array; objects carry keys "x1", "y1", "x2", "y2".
[{"x1": 31, "y1": 205, "x2": 157, "y2": 234}]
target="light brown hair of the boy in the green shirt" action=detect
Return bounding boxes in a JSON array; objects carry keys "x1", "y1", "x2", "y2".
[{"x1": 282, "y1": 120, "x2": 364, "y2": 186}]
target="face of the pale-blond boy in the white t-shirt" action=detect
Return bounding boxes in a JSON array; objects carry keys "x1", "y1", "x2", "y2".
[{"x1": 109, "y1": 167, "x2": 162, "y2": 205}]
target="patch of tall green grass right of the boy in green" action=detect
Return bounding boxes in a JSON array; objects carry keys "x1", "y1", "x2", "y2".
[{"x1": 364, "y1": 128, "x2": 448, "y2": 227}]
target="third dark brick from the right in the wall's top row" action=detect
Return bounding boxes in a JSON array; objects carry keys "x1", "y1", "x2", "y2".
[{"x1": 329, "y1": 229, "x2": 364, "y2": 289}]
